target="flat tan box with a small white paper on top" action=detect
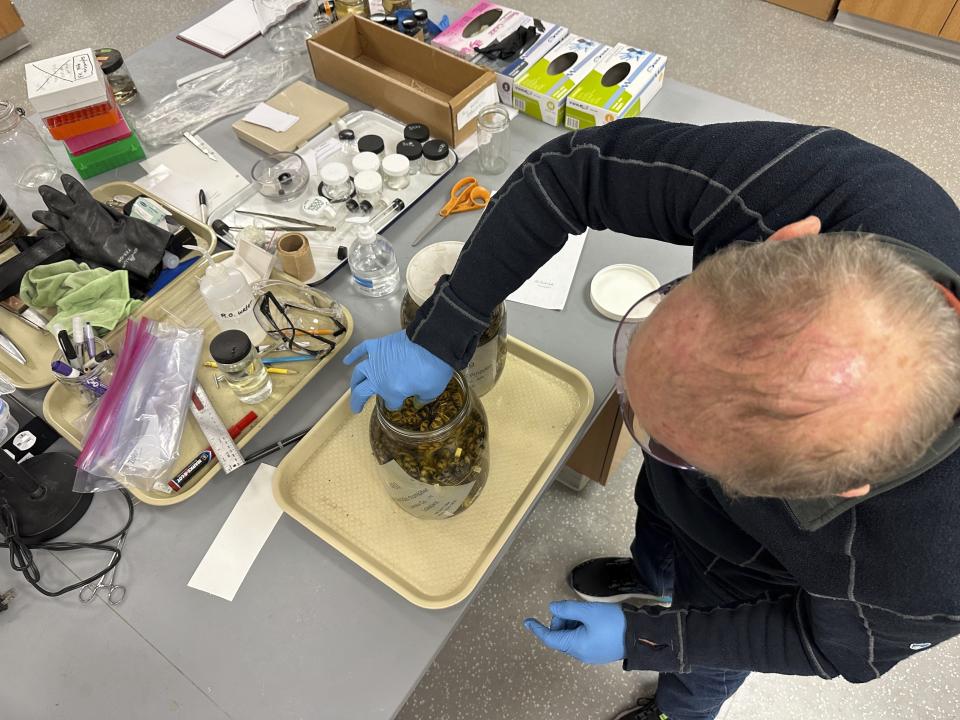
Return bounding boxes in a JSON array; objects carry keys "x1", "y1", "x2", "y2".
[{"x1": 233, "y1": 80, "x2": 350, "y2": 153}]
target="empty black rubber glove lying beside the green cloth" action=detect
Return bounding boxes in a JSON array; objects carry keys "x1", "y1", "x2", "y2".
[{"x1": 33, "y1": 175, "x2": 173, "y2": 279}]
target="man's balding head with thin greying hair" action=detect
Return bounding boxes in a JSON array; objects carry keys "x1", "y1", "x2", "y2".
[{"x1": 624, "y1": 228, "x2": 960, "y2": 498}]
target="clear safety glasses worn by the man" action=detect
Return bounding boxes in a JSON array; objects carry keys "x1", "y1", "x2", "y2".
[{"x1": 613, "y1": 275, "x2": 696, "y2": 470}]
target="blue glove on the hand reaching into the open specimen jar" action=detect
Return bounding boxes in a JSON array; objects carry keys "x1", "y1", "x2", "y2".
[{"x1": 343, "y1": 330, "x2": 453, "y2": 413}]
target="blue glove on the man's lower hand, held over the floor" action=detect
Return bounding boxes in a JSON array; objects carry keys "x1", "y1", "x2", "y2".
[{"x1": 523, "y1": 600, "x2": 627, "y2": 665}]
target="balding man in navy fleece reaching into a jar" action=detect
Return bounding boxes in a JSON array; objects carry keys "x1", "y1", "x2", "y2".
[{"x1": 348, "y1": 119, "x2": 960, "y2": 720}]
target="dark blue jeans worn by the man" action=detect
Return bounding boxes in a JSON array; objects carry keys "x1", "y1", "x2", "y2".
[{"x1": 630, "y1": 486, "x2": 750, "y2": 720}]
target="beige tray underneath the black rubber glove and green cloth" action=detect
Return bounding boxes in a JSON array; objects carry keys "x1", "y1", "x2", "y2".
[{"x1": 0, "y1": 181, "x2": 217, "y2": 390}]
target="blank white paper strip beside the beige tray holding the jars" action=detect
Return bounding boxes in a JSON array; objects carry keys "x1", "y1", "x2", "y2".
[{"x1": 187, "y1": 465, "x2": 283, "y2": 601}]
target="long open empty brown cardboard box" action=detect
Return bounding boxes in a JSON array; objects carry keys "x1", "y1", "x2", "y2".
[{"x1": 307, "y1": 16, "x2": 498, "y2": 146}]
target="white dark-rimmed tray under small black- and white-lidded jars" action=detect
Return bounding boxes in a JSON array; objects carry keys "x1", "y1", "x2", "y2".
[{"x1": 210, "y1": 110, "x2": 458, "y2": 285}]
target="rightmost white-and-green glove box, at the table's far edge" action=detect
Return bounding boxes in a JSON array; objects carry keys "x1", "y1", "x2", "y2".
[{"x1": 566, "y1": 43, "x2": 667, "y2": 130}]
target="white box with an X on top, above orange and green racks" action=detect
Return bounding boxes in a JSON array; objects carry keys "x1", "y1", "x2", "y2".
[{"x1": 24, "y1": 48, "x2": 110, "y2": 116}]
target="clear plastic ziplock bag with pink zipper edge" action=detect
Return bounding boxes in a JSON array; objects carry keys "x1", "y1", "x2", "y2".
[{"x1": 73, "y1": 318, "x2": 203, "y2": 492}]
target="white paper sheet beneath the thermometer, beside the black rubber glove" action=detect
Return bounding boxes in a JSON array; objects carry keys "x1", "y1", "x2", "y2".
[{"x1": 137, "y1": 142, "x2": 249, "y2": 218}]
